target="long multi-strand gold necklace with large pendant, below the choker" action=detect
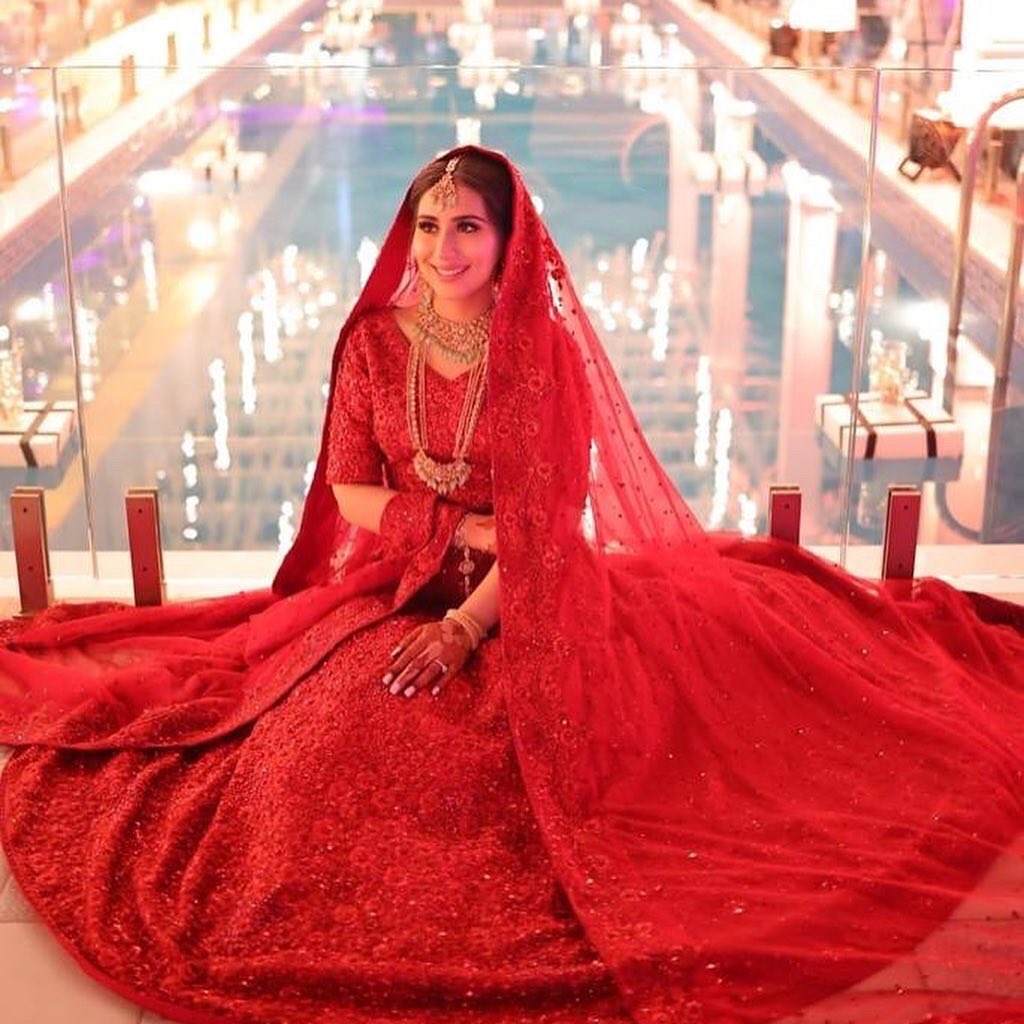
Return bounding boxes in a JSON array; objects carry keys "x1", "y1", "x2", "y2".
[{"x1": 406, "y1": 335, "x2": 487, "y2": 496}]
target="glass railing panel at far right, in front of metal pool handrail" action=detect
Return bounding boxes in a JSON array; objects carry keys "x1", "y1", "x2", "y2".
[{"x1": 851, "y1": 70, "x2": 1024, "y2": 586}]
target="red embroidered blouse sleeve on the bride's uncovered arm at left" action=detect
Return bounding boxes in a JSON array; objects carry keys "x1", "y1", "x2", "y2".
[{"x1": 327, "y1": 323, "x2": 384, "y2": 483}]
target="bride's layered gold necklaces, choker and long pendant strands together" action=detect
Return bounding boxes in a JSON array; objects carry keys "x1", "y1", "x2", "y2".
[{"x1": 406, "y1": 291, "x2": 490, "y2": 495}]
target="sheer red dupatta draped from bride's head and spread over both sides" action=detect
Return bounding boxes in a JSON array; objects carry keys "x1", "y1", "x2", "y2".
[{"x1": 0, "y1": 151, "x2": 1024, "y2": 1024}]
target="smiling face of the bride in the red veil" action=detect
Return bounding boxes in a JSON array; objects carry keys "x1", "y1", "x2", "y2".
[{"x1": 412, "y1": 183, "x2": 504, "y2": 315}]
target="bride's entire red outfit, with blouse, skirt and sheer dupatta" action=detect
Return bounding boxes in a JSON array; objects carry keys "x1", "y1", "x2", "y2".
[{"x1": 0, "y1": 146, "x2": 1024, "y2": 1024}]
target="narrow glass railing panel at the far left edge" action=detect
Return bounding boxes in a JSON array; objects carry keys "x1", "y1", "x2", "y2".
[{"x1": 0, "y1": 69, "x2": 90, "y2": 574}]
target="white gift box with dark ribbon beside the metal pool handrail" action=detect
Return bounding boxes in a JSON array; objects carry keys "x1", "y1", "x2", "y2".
[{"x1": 815, "y1": 391, "x2": 964, "y2": 461}]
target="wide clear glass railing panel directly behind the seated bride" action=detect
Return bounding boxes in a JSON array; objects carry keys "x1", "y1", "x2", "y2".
[{"x1": 25, "y1": 58, "x2": 868, "y2": 577}]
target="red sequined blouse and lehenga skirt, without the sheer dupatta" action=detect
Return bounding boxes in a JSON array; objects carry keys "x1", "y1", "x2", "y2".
[{"x1": 4, "y1": 314, "x2": 630, "y2": 1024}]
